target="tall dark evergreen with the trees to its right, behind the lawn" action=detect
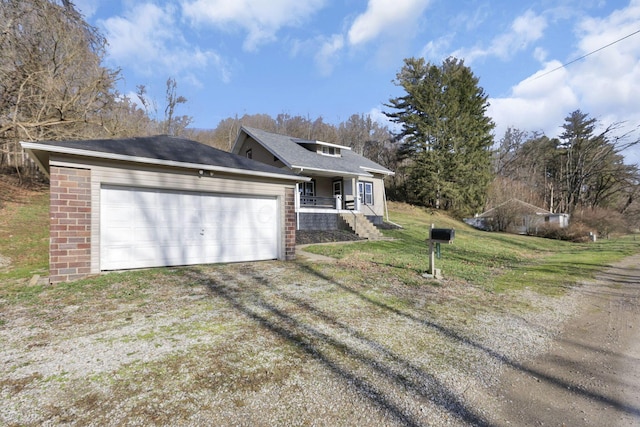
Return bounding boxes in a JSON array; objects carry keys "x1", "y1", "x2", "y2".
[{"x1": 387, "y1": 58, "x2": 640, "y2": 235}]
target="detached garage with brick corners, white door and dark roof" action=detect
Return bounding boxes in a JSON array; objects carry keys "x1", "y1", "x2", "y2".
[{"x1": 21, "y1": 136, "x2": 309, "y2": 283}]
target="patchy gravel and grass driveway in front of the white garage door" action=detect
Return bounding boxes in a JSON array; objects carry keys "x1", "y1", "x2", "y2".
[{"x1": 0, "y1": 254, "x2": 637, "y2": 426}]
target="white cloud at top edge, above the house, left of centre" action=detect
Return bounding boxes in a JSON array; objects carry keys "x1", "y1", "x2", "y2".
[{"x1": 182, "y1": 0, "x2": 325, "y2": 51}]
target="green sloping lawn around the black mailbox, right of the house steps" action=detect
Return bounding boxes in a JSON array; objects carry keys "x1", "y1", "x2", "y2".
[{"x1": 305, "y1": 204, "x2": 640, "y2": 295}]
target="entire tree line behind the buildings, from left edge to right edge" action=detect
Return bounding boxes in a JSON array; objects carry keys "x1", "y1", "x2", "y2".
[{"x1": 0, "y1": 0, "x2": 640, "y2": 236}]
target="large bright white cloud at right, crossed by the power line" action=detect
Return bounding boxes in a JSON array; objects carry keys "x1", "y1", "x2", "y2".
[{"x1": 489, "y1": 0, "x2": 640, "y2": 163}]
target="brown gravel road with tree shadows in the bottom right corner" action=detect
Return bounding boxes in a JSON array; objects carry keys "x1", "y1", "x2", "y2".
[{"x1": 484, "y1": 252, "x2": 640, "y2": 426}]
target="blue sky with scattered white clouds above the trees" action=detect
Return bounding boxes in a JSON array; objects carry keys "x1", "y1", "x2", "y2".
[{"x1": 74, "y1": 0, "x2": 640, "y2": 164}]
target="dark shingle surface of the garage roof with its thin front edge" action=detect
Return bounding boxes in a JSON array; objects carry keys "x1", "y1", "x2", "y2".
[{"x1": 23, "y1": 135, "x2": 295, "y2": 176}]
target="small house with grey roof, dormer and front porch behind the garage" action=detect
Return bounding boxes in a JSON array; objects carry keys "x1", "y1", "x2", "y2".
[{"x1": 232, "y1": 126, "x2": 394, "y2": 238}]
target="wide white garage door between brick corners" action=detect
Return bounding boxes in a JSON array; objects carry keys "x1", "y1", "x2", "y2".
[{"x1": 100, "y1": 186, "x2": 279, "y2": 270}]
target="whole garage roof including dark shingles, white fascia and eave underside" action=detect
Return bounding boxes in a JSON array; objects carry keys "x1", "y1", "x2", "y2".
[{"x1": 21, "y1": 135, "x2": 304, "y2": 181}]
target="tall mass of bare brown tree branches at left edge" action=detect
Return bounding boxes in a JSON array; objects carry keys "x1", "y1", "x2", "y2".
[{"x1": 0, "y1": 0, "x2": 119, "y2": 149}]
